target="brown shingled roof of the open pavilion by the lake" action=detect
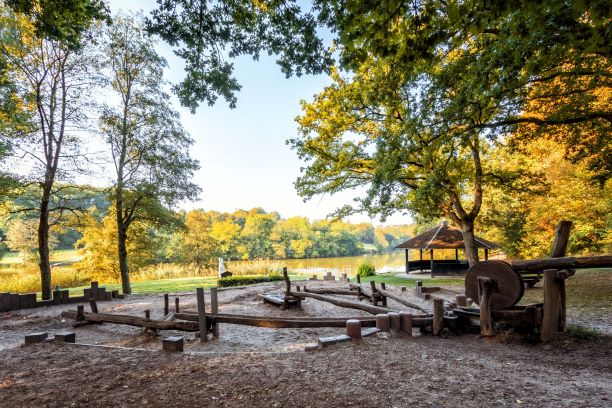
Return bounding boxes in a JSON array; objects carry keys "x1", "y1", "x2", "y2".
[{"x1": 395, "y1": 221, "x2": 499, "y2": 249}]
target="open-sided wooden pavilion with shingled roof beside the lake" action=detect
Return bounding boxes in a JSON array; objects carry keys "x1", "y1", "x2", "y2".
[{"x1": 395, "y1": 221, "x2": 499, "y2": 277}]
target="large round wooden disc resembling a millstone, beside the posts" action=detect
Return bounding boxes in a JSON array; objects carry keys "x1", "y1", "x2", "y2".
[{"x1": 465, "y1": 261, "x2": 525, "y2": 310}]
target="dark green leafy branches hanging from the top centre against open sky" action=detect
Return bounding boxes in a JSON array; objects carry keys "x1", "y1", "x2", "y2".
[{"x1": 147, "y1": 0, "x2": 331, "y2": 112}]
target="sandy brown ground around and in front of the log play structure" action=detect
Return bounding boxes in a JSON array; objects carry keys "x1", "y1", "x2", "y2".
[{"x1": 0, "y1": 283, "x2": 612, "y2": 407}]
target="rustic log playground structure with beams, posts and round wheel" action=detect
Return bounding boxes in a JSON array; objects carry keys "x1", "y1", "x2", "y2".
[{"x1": 53, "y1": 221, "x2": 612, "y2": 350}]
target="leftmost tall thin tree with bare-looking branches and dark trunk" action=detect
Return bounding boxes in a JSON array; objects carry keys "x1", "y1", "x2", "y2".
[{"x1": 0, "y1": 7, "x2": 97, "y2": 299}]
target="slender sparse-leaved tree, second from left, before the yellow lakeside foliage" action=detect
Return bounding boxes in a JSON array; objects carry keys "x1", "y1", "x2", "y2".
[{"x1": 100, "y1": 15, "x2": 200, "y2": 293}]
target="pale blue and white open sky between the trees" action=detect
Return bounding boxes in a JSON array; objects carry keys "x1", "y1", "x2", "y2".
[{"x1": 108, "y1": 0, "x2": 412, "y2": 225}]
